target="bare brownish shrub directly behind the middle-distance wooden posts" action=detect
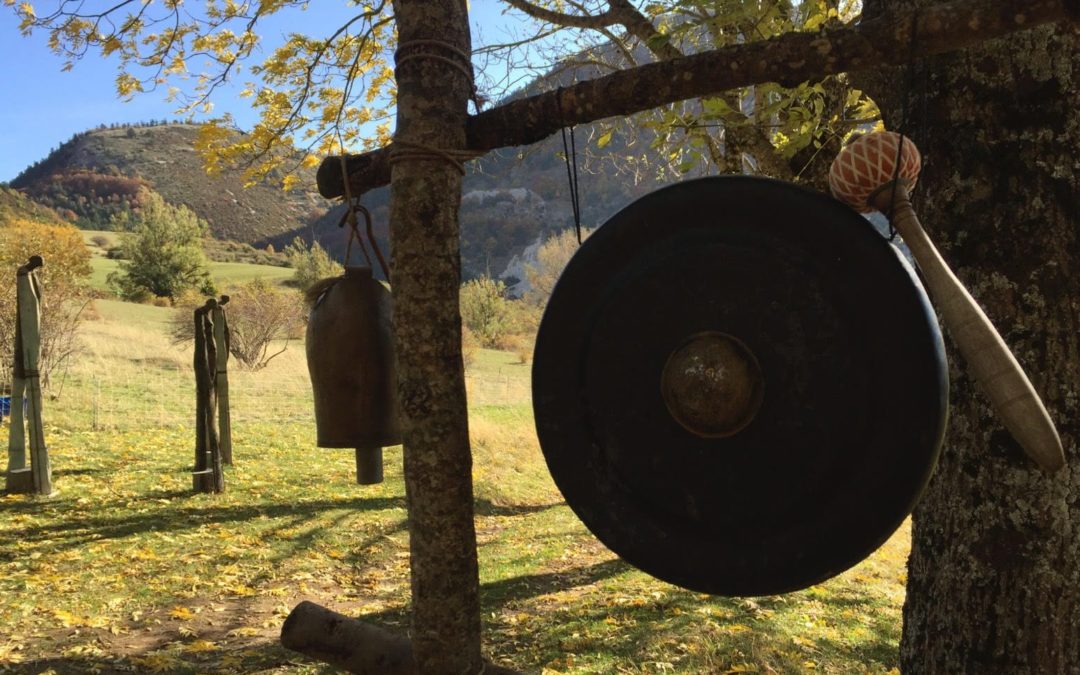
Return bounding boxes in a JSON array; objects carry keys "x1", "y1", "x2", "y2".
[{"x1": 172, "y1": 279, "x2": 303, "y2": 370}]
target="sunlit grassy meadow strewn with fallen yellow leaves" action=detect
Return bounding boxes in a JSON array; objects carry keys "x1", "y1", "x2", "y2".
[{"x1": 0, "y1": 259, "x2": 909, "y2": 674}]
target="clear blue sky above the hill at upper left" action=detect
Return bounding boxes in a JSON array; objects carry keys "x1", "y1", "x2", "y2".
[{"x1": 0, "y1": 0, "x2": 537, "y2": 181}]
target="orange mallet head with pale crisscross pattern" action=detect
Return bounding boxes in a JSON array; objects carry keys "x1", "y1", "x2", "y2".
[{"x1": 828, "y1": 132, "x2": 922, "y2": 213}]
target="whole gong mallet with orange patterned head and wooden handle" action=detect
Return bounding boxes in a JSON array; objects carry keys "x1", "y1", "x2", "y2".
[{"x1": 828, "y1": 132, "x2": 1065, "y2": 471}]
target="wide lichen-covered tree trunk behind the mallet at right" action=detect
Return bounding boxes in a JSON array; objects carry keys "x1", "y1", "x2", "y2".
[{"x1": 865, "y1": 0, "x2": 1080, "y2": 675}]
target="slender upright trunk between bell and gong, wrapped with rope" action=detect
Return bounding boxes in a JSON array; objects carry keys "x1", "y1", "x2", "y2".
[{"x1": 390, "y1": 0, "x2": 483, "y2": 675}]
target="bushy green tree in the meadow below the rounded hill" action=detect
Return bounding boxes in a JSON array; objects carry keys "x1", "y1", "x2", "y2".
[{"x1": 108, "y1": 186, "x2": 214, "y2": 300}]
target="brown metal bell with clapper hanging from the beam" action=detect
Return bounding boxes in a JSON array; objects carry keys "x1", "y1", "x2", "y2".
[{"x1": 307, "y1": 267, "x2": 401, "y2": 485}]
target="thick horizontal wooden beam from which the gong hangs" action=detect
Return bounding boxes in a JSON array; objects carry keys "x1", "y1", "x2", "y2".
[{"x1": 316, "y1": 0, "x2": 1080, "y2": 198}]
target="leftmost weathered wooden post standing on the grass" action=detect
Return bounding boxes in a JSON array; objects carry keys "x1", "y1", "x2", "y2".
[{"x1": 6, "y1": 256, "x2": 53, "y2": 495}]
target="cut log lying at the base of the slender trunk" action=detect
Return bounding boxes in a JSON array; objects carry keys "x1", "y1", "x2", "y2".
[{"x1": 281, "y1": 600, "x2": 518, "y2": 675}]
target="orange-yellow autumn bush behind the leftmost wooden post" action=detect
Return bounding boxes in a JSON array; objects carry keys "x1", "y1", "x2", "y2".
[{"x1": 0, "y1": 220, "x2": 91, "y2": 387}]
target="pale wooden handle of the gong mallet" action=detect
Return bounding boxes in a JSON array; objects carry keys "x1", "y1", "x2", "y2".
[{"x1": 870, "y1": 180, "x2": 1065, "y2": 471}]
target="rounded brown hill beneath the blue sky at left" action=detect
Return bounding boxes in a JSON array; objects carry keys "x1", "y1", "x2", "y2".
[{"x1": 12, "y1": 124, "x2": 329, "y2": 245}]
